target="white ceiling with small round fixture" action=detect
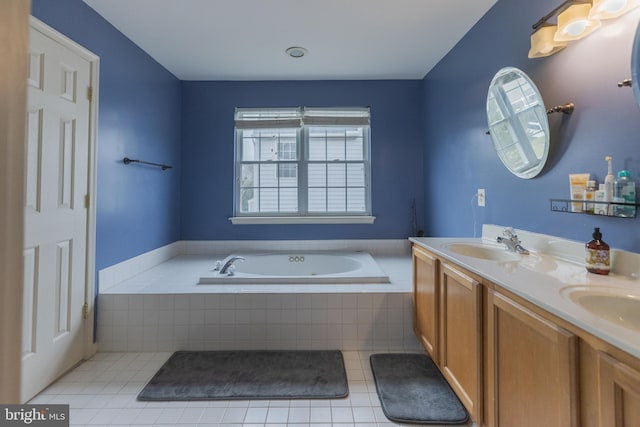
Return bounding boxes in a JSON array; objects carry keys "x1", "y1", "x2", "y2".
[{"x1": 84, "y1": 0, "x2": 497, "y2": 80}]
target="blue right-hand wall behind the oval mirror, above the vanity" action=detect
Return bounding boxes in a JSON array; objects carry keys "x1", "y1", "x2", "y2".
[{"x1": 423, "y1": 0, "x2": 640, "y2": 252}]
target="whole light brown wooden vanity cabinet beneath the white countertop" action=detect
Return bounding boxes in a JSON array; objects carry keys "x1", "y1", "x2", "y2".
[{"x1": 413, "y1": 245, "x2": 640, "y2": 427}]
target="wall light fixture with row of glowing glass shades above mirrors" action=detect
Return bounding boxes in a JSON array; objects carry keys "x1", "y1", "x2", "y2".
[{"x1": 529, "y1": 0, "x2": 640, "y2": 58}]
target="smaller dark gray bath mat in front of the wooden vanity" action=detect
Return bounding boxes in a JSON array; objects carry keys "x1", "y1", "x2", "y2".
[{"x1": 369, "y1": 353, "x2": 468, "y2": 424}]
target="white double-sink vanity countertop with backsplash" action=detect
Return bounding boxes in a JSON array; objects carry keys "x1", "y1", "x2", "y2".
[{"x1": 409, "y1": 226, "x2": 640, "y2": 358}]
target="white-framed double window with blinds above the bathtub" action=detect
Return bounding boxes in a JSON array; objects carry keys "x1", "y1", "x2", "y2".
[{"x1": 232, "y1": 108, "x2": 373, "y2": 223}]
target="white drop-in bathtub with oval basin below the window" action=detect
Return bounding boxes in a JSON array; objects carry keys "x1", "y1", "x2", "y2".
[{"x1": 199, "y1": 251, "x2": 390, "y2": 285}]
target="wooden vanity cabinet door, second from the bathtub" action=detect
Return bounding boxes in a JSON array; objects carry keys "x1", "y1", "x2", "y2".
[{"x1": 439, "y1": 263, "x2": 482, "y2": 425}]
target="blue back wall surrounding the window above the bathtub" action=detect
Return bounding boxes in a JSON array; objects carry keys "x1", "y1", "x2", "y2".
[{"x1": 182, "y1": 80, "x2": 423, "y2": 240}]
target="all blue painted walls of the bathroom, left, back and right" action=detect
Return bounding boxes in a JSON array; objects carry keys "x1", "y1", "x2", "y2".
[{"x1": 32, "y1": 0, "x2": 640, "y2": 269}]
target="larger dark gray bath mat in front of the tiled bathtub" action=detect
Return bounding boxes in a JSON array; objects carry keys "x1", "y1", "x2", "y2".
[{"x1": 138, "y1": 350, "x2": 349, "y2": 401}]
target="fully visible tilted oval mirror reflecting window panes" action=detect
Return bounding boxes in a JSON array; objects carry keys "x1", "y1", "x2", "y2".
[{"x1": 487, "y1": 67, "x2": 549, "y2": 179}]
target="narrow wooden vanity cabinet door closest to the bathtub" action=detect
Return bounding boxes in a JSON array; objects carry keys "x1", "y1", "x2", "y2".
[{"x1": 413, "y1": 246, "x2": 438, "y2": 363}]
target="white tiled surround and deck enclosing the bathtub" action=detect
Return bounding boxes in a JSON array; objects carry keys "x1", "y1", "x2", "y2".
[{"x1": 98, "y1": 240, "x2": 420, "y2": 351}]
